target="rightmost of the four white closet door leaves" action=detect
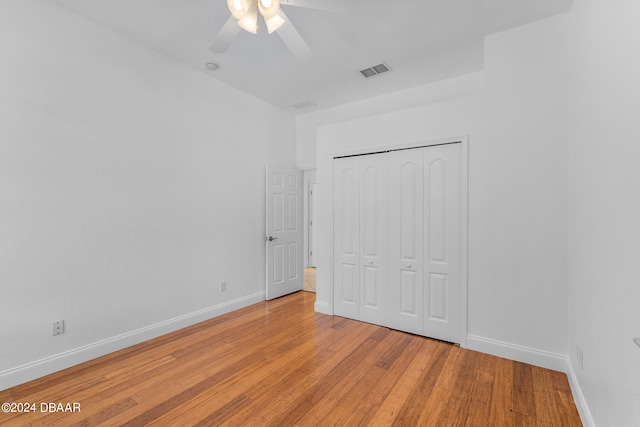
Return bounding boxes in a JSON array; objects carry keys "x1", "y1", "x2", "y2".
[{"x1": 424, "y1": 144, "x2": 461, "y2": 343}]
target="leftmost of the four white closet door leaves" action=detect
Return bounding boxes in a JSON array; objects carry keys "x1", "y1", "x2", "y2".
[{"x1": 333, "y1": 157, "x2": 360, "y2": 319}]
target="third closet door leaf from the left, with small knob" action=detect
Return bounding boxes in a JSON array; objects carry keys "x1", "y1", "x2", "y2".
[{"x1": 387, "y1": 150, "x2": 424, "y2": 334}]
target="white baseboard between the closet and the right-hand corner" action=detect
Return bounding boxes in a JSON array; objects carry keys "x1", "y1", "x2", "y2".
[{"x1": 467, "y1": 335, "x2": 568, "y2": 372}]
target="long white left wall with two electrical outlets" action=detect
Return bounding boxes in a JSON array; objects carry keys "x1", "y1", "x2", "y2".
[{"x1": 0, "y1": 0, "x2": 295, "y2": 389}]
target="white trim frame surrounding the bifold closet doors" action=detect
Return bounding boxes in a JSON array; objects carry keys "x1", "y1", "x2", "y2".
[{"x1": 330, "y1": 135, "x2": 469, "y2": 348}]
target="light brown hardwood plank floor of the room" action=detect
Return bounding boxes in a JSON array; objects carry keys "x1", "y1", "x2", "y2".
[{"x1": 0, "y1": 292, "x2": 581, "y2": 427}]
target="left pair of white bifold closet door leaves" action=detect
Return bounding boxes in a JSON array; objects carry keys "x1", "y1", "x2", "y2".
[{"x1": 334, "y1": 154, "x2": 388, "y2": 324}]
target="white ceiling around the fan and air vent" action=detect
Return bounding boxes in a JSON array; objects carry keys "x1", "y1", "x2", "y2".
[{"x1": 51, "y1": 0, "x2": 571, "y2": 114}]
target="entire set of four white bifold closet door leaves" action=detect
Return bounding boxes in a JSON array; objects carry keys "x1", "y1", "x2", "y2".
[{"x1": 333, "y1": 143, "x2": 462, "y2": 343}]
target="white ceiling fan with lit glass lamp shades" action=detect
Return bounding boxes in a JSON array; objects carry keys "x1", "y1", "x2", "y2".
[{"x1": 209, "y1": 0, "x2": 340, "y2": 61}]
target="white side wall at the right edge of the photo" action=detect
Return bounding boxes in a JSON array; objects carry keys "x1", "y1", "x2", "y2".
[{"x1": 569, "y1": 0, "x2": 640, "y2": 426}]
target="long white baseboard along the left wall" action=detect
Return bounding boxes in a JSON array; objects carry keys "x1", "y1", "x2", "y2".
[{"x1": 0, "y1": 291, "x2": 265, "y2": 390}]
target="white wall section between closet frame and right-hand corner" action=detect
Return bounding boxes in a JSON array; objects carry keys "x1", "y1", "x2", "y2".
[{"x1": 469, "y1": 15, "x2": 567, "y2": 362}]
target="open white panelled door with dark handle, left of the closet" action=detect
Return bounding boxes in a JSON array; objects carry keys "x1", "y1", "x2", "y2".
[{"x1": 265, "y1": 166, "x2": 304, "y2": 299}]
